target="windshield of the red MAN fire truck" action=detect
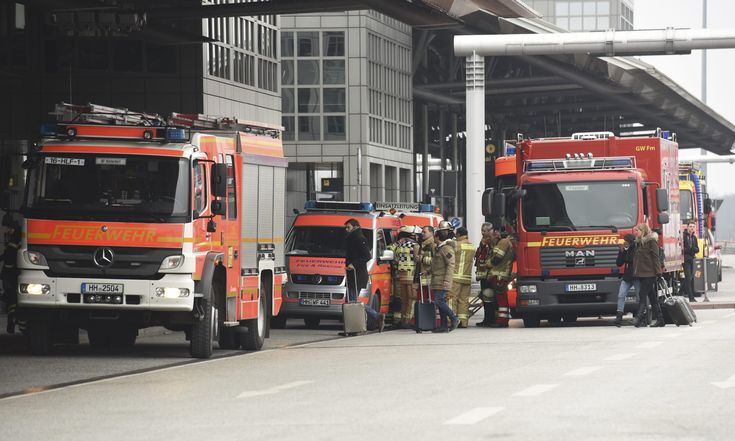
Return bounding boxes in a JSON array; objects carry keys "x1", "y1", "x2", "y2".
[{"x1": 522, "y1": 181, "x2": 638, "y2": 231}]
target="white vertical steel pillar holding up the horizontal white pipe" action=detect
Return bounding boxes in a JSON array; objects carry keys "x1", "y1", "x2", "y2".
[{"x1": 465, "y1": 52, "x2": 485, "y2": 248}]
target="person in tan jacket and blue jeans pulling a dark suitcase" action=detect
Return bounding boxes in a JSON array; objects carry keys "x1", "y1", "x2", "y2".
[{"x1": 431, "y1": 221, "x2": 459, "y2": 332}]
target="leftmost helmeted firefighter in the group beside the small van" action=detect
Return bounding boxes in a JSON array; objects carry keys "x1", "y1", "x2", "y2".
[{"x1": 388, "y1": 225, "x2": 419, "y2": 328}]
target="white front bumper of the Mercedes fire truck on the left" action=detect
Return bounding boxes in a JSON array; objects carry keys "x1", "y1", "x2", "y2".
[{"x1": 18, "y1": 270, "x2": 195, "y2": 312}]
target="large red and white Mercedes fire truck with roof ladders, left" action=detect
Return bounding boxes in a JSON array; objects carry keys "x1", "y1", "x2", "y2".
[{"x1": 19, "y1": 104, "x2": 287, "y2": 358}]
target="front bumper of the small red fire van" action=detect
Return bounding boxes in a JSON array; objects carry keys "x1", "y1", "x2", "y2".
[{"x1": 279, "y1": 282, "x2": 346, "y2": 320}]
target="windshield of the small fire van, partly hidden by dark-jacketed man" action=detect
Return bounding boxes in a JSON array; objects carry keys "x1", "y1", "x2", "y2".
[{"x1": 286, "y1": 226, "x2": 373, "y2": 257}]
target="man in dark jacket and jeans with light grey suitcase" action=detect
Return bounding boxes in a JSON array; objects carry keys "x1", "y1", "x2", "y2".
[{"x1": 345, "y1": 219, "x2": 384, "y2": 332}]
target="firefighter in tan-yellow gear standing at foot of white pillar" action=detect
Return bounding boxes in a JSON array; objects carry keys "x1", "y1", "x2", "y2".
[{"x1": 449, "y1": 227, "x2": 475, "y2": 328}]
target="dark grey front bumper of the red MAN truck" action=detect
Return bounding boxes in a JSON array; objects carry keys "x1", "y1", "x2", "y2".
[{"x1": 516, "y1": 277, "x2": 638, "y2": 318}]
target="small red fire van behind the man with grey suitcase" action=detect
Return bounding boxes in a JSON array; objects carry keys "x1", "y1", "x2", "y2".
[{"x1": 274, "y1": 201, "x2": 401, "y2": 328}]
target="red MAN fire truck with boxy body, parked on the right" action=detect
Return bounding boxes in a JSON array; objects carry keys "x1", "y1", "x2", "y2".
[{"x1": 483, "y1": 131, "x2": 683, "y2": 327}]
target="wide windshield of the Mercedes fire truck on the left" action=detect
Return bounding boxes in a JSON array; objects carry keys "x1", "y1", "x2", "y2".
[{"x1": 25, "y1": 153, "x2": 191, "y2": 223}]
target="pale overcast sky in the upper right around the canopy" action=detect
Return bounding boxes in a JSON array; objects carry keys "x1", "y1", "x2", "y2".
[{"x1": 634, "y1": 0, "x2": 735, "y2": 198}]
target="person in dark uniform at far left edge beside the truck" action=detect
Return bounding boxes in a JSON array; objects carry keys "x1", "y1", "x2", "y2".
[{"x1": 0, "y1": 214, "x2": 25, "y2": 334}]
